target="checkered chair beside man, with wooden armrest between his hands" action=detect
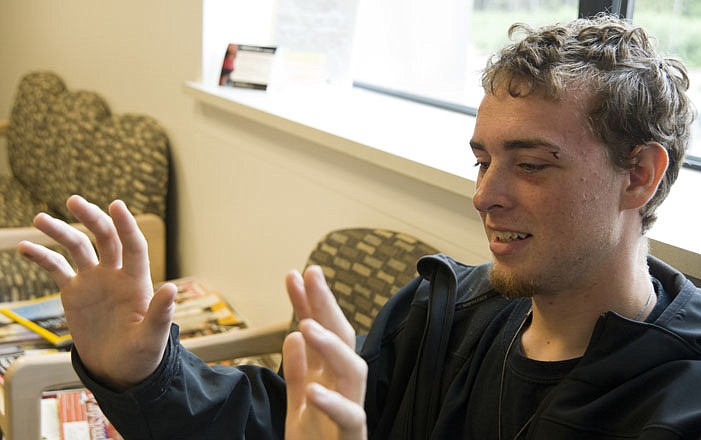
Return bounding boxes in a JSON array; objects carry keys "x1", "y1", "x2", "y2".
[{"x1": 185, "y1": 228, "x2": 439, "y2": 369}]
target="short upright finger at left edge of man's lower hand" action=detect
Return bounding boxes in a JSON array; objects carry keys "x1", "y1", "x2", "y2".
[{"x1": 282, "y1": 332, "x2": 307, "y2": 414}]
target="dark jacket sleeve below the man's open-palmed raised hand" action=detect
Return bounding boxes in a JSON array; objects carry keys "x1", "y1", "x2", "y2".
[{"x1": 72, "y1": 325, "x2": 286, "y2": 439}]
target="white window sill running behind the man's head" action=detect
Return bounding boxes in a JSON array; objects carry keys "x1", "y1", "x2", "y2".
[{"x1": 185, "y1": 82, "x2": 701, "y2": 278}]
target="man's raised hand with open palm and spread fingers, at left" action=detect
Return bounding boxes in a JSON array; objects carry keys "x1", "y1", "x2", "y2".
[{"x1": 18, "y1": 196, "x2": 176, "y2": 389}]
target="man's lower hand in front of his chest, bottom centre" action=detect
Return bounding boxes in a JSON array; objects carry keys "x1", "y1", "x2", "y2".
[{"x1": 283, "y1": 266, "x2": 367, "y2": 440}]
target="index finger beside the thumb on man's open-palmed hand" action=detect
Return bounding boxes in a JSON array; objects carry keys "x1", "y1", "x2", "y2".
[{"x1": 109, "y1": 200, "x2": 150, "y2": 277}]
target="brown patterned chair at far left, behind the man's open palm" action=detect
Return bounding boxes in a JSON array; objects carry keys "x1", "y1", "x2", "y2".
[{"x1": 0, "y1": 72, "x2": 169, "y2": 301}]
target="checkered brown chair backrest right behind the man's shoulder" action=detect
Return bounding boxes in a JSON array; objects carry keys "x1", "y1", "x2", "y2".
[{"x1": 307, "y1": 228, "x2": 438, "y2": 334}]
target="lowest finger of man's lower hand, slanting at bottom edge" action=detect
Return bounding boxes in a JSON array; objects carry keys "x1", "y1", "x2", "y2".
[{"x1": 306, "y1": 382, "x2": 366, "y2": 438}]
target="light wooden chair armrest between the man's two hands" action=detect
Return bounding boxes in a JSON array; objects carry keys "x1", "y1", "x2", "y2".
[{"x1": 181, "y1": 321, "x2": 290, "y2": 362}]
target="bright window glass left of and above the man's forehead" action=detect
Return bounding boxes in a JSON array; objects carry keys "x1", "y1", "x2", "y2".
[{"x1": 354, "y1": 0, "x2": 578, "y2": 107}]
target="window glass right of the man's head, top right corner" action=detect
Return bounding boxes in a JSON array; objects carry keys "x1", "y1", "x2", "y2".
[{"x1": 633, "y1": 0, "x2": 701, "y2": 161}]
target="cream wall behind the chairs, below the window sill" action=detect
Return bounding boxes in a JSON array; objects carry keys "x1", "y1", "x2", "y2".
[{"x1": 0, "y1": 0, "x2": 487, "y2": 325}]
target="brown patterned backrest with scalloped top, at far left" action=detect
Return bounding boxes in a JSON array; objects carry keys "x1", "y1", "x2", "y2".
[{"x1": 7, "y1": 72, "x2": 169, "y2": 221}]
